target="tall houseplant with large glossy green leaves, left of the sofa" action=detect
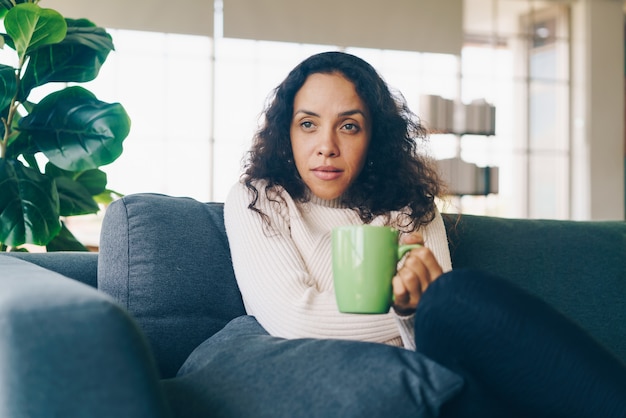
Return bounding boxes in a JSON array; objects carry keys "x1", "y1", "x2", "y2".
[{"x1": 0, "y1": 0, "x2": 130, "y2": 251}]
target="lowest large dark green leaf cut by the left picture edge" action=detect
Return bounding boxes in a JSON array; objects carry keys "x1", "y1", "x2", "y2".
[{"x1": 0, "y1": 159, "x2": 61, "y2": 247}]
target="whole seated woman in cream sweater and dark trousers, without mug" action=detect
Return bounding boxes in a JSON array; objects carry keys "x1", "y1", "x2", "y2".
[{"x1": 225, "y1": 52, "x2": 626, "y2": 416}]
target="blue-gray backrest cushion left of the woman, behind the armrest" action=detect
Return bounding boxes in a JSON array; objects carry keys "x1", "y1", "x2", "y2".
[{"x1": 98, "y1": 193, "x2": 245, "y2": 377}]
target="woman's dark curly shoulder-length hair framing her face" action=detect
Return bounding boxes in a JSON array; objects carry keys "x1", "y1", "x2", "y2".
[{"x1": 242, "y1": 52, "x2": 443, "y2": 230}]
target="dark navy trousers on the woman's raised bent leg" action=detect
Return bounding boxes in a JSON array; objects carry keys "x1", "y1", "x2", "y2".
[{"x1": 415, "y1": 270, "x2": 626, "y2": 418}]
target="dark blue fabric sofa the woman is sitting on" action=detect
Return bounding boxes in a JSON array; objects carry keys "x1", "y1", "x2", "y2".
[{"x1": 0, "y1": 194, "x2": 626, "y2": 418}]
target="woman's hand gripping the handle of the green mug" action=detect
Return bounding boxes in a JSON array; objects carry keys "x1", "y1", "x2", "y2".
[{"x1": 392, "y1": 233, "x2": 443, "y2": 315}]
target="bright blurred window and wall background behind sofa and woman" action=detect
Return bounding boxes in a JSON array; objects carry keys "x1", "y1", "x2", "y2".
[{"x1": 28, "y1": 0, "x2": 625, "y2": 247}]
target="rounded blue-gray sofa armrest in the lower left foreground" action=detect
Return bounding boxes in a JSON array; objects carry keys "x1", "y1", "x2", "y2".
[{"x1": 0, "y1": 257, "x2": 170, "y2": 417}]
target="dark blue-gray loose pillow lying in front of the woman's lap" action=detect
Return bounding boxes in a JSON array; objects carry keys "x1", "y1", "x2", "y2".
[{"x1": 164, "y1": 316, "x2": 463, "y2": 418}]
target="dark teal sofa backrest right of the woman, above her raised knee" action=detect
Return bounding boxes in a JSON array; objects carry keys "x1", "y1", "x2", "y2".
[{"x1": 444, "y1": 215, "x2": 626, "y2": 362}]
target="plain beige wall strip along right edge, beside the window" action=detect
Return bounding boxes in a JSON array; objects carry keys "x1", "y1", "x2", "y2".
[{"x1": 571, "y1": 0, "x2": 625, "y2": 220}]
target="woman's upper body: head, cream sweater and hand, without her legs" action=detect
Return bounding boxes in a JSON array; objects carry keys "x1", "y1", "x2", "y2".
[{"x1": 227, "y1": 49, "x2": 444, "y2": 347}]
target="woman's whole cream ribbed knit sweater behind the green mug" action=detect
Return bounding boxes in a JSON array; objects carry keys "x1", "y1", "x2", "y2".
[{"x1": 224, "y1": 183, "x2": 452, "y2": 349}]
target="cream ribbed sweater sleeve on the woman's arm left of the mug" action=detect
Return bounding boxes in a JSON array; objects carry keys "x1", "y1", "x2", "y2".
[{"x1": 224, "y1": 184, "x2": 401, "y2": 345}]
